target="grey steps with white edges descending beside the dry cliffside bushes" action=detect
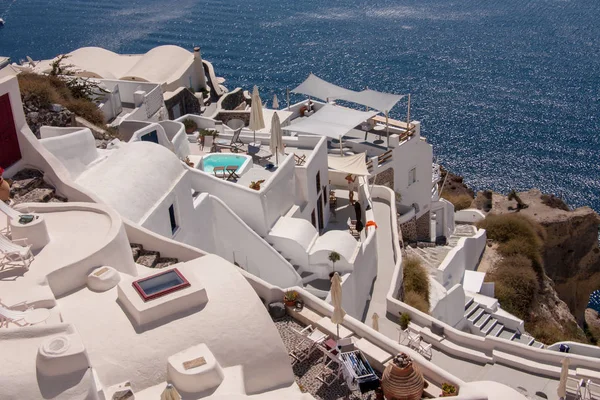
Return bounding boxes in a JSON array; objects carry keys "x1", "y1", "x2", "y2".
[{"x1": 465, "y1": 297, "x2": 544, "y2": 348}]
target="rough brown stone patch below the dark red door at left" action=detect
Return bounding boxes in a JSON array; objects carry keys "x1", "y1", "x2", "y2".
[{"x1": 7, "y1": 168, "x2": 67, "y2": 205}]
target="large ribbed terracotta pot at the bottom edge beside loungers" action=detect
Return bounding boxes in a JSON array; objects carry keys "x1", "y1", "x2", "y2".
[{"x1": 381, "y1": 358, "x2": 425, "y2": 400}]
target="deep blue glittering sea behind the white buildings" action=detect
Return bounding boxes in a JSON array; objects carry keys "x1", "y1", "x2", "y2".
[{"x1": 0, "y1": 0, "x2": 600, "y2": 211}]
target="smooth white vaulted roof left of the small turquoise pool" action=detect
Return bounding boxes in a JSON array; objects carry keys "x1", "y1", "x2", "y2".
[{"x1": 76, "y1": 142, "x2": 186, "y2": 223}]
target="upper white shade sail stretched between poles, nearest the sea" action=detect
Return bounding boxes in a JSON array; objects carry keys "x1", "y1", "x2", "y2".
[{"x1": 292, "y1": 74, "x2": 404, "y2": 112}]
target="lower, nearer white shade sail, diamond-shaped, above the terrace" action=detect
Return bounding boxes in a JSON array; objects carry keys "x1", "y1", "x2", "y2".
[{"x1": 282, "y1": 104, "x2": 377, "y2": 139}]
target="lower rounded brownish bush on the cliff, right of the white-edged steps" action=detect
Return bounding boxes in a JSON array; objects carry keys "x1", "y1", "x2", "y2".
[{"x1": 486, "y1": 255, "x2": 539, "y2": 319}]
